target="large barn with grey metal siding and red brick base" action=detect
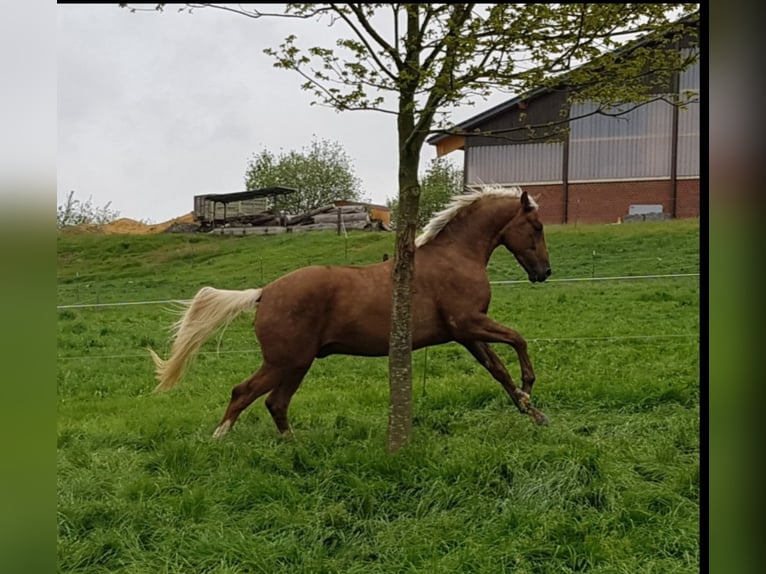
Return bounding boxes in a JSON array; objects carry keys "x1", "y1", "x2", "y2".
[{"x1": 428, "y1": 14, "x2": 700, "y2": 223}]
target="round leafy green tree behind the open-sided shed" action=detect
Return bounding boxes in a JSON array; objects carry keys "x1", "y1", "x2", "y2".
[{"x1": 245, "y1": 139, "x2": 361, "y2": 214}]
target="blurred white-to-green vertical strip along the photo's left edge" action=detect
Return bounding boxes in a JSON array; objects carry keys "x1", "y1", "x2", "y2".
[{"x1": 0, "y1": 0, "x2": 57, "y2": 573}]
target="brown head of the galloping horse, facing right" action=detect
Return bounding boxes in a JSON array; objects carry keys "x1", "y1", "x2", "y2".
[{"x1": 500, "y1": 191, "x2": 551, "y2": 283}]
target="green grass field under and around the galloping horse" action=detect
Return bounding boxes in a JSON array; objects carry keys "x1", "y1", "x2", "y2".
[{"x1": 57, "y1": 221, "x2": 700, "y2": 574}]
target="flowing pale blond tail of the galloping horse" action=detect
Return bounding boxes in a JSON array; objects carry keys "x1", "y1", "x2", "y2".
[{"x1": 149, "y1": 287, "x2": 262, "y2": 391}]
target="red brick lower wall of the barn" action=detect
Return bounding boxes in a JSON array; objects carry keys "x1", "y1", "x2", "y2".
[{"x1": 524, "y1": 179, "x2": 699, "y2": 224}]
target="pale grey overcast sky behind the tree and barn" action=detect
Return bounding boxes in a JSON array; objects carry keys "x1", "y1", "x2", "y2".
[{"x1": 57, "y1": 4, "x2": 509, "y2": 223}]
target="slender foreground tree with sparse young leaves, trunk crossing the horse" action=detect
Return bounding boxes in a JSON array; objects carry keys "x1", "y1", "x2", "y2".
[{"x1": 121, "y1": 3, "x2": 699, "y2": 452}]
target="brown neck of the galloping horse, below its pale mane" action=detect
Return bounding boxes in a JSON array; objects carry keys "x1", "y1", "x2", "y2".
[{"x1": 434, "y1": 198, "x2": 519, "y2": 266}]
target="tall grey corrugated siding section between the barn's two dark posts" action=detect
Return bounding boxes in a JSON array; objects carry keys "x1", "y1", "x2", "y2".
[{"x1": 569, "y1": 102, "x2": 673, "y2": 182}]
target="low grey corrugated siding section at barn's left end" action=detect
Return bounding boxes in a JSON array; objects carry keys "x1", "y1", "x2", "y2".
[{"x1": 466, "y1": 143, "x2": 564, "y2": 183}]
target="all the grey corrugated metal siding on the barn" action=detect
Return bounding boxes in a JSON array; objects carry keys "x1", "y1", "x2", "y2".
[{"x1": 465, "y1": 49, "x2": 700, "y2": 187}]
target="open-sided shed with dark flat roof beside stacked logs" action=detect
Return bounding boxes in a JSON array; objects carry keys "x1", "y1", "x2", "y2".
[{"x1": 194, "y1": 187, "x2": 297, "y2": 229}]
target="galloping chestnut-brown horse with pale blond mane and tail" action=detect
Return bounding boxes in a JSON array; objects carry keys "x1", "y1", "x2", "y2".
[{"x1": 149, "y1": 187, "x2": 551, "y2": 438}]
